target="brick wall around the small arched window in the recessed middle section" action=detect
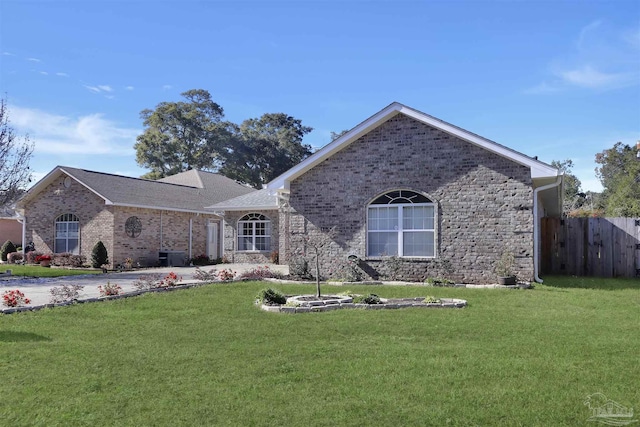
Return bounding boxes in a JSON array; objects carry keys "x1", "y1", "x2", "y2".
[{"x1": 222, "y1": 210, "x2": 280, "y2": 264}]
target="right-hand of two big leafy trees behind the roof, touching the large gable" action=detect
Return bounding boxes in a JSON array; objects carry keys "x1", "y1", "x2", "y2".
[{"x1": 220, "y1": 113, "x2": 313, "y2": 189}]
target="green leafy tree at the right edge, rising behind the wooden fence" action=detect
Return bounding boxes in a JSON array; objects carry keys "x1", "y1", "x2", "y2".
[{"x1": 596, "y1": 142, "x2": 640, "y2": 217}]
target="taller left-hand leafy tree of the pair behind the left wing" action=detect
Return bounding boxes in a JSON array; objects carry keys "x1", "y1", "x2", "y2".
[{"x1": 134, "y1": 89, "x2": 231, "y2": 179}]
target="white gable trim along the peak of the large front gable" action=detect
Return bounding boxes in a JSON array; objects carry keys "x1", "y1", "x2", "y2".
[{"x1": 267, "y1": 102, "x2": 559, "y2": 191}]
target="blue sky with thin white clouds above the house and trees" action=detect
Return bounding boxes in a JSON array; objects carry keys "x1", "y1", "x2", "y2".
[{"x1": 0, "y1": 0, "x2": 640, "y2": 191}]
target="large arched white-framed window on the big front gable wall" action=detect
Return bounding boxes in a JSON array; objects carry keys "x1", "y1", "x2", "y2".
[{"x1": 367, "y1": 190, "x2": 436, "y2": 258}]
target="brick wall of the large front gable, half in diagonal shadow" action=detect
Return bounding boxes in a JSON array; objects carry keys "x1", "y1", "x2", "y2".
[{"x1": 281, "y1": 114, "x2": 533, "y2": 283}]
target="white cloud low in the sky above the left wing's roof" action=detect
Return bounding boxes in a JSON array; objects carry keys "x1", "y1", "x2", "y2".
[{"x1": 11, "y1": 106, "x2": 140, "y2": 156}]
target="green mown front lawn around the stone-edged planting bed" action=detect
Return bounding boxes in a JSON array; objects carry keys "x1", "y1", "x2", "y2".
[{"x1": 0, "y1": 277, "x2": 640, "y2": 426}]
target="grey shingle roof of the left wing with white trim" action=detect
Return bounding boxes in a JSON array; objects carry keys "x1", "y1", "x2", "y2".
[{"x1": 16, "y1": 166, "x2": 256, "y2": 213}]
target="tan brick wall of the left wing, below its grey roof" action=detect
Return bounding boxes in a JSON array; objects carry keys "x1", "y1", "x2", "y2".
[{"x1": 25, "y1": 176, "x2": 219, "y2": 268}]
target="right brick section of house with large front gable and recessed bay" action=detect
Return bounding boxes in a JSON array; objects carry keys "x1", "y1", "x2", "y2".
[{"x1": 209, "y1": 103, "x2": 562, "y2": 283}]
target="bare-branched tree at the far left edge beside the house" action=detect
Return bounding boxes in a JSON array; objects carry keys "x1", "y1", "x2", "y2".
[{"x1": 0, "y1": 99, "x2": 33, "y2": 206}]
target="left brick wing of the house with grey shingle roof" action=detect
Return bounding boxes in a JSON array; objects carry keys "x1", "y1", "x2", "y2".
[{"x1": 16, "y1": 166, "x2": 256, "y2": 268}]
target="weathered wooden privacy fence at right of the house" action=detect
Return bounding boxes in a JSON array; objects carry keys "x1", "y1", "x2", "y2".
[{"x1": 540, "y1": 218, "x2": 640, "y2": 277}]
